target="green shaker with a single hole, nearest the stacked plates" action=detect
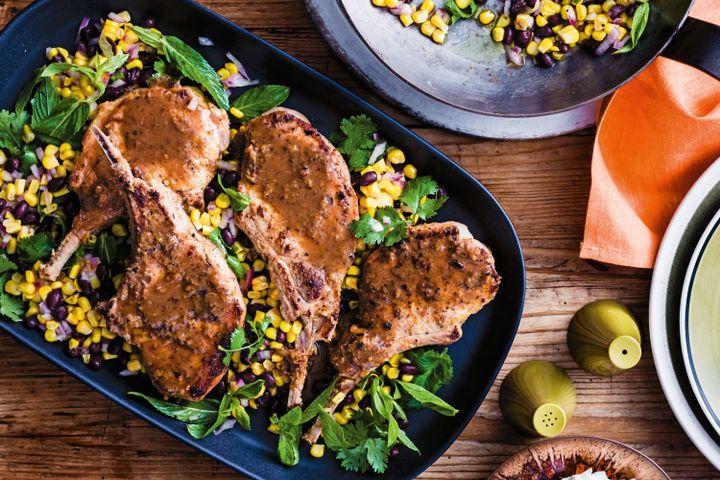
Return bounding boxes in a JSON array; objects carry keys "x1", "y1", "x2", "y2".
[{"x1": 568, "y1": 300, "x2": 642, "y2": 377}]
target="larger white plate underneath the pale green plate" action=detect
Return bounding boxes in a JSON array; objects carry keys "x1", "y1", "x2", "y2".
[{"x1": 650, "y1": 161, "x2": 720, "y2": 469}]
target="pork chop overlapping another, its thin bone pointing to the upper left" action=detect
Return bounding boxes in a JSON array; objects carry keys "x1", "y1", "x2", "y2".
[{"x1": 93, "y1": 127, "x2": 245, "y2": 401}]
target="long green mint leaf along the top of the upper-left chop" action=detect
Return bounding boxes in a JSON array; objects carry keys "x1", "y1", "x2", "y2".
[{"x1": 132, "y1": 26, "x2": 230, "y2": 110}]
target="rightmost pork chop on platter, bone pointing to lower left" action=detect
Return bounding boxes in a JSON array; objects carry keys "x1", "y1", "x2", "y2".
[{"x1": 305, "y1": 222, "x2": 500, "y2": 443}]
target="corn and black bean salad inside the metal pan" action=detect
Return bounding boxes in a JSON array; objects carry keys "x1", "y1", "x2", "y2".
[{"x1": 372, "y1": 0, "x2": 650, "y2": 67}]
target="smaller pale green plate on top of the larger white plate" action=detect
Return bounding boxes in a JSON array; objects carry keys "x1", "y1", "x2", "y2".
[{"x1": 680, "y1": 206, "x2": 720, "y2": 434}]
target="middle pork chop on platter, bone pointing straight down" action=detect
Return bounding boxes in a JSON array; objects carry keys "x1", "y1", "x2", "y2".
[{"x1": 235, "y1": 110, "x2": 358, "y2": 405}]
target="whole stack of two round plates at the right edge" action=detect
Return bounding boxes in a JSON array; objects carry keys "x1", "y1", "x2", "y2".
[{"x1": 650, "y1": 160, "x2": 720, "y2": 469}]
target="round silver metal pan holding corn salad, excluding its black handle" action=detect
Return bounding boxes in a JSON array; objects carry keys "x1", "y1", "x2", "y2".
[{"x1": 306, "y1": 0, "x2": 720, "y2": 138}]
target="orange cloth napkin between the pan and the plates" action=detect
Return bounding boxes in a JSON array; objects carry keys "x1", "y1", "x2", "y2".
[{"x1": 580, "y1": 0, "x2": 720, "y2": 268}]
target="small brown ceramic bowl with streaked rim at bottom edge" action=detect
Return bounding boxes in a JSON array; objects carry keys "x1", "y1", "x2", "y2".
[{"x1": 489, "y1": 437, "x2": 670, "y2": 480}]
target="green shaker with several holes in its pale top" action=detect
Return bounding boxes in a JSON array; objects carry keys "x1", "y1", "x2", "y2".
[{"x1": 500, "y1": 360, "x2": 576, "y2": 437}]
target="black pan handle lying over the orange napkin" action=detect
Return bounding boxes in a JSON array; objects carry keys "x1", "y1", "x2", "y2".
[{"x1": 662, "y1": 17, "x2": 720, "y2": 80}]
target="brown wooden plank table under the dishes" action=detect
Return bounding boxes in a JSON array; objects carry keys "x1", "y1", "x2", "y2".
[{"x1": 0, "y1": 0, "x2": 720, "y2": 480}]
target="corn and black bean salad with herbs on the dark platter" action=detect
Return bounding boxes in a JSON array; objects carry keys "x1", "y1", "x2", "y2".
[{"x1": 0, "y1": 12, "x2": 455, "y2": 473}]
